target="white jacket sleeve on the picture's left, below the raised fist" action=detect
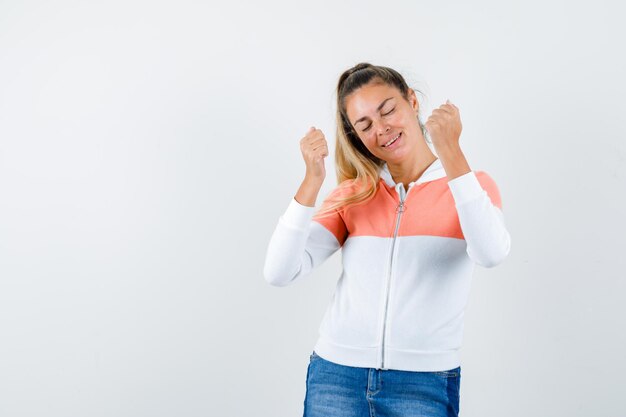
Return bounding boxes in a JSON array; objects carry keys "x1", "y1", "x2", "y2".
[{"x1": 263, "y1": 198, "x2": 341, "y2": 287}]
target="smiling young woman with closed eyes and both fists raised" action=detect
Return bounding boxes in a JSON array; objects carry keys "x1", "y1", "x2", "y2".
[{"x1": 264, "y1": 63, "x2": 511, "y2": 417}]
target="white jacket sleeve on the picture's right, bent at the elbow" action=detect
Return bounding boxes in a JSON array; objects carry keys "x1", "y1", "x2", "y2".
[{"x1": 448, "y1": 171, "x2": 511, "y2": 268}]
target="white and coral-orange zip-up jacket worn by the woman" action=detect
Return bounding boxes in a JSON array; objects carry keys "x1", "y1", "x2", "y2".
[{"x1": 263, "y1": 159, "x2": 511, "y2": 371}]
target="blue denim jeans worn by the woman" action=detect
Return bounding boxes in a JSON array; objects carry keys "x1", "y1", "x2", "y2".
[{"x1": 304, "y1": 352, "x2": 461, "y2": 417}]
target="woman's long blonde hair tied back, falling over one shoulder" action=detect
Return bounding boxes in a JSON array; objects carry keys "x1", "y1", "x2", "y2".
[{"x1": 316, "y1": 62, "x2": 429, "y2": 217}]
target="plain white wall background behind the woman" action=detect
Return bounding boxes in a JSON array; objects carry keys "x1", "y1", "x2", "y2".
[{"x1": 0, "y1": 0, "x2": 626, "y2": 417}]
